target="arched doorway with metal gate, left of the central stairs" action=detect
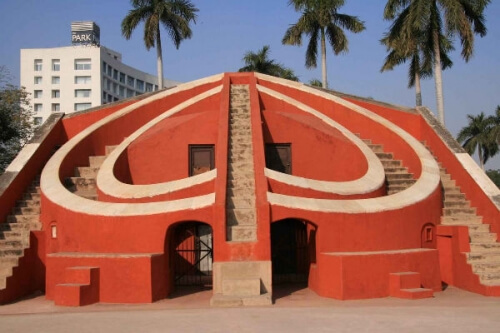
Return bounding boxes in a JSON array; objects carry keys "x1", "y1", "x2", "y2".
[{"x1": 171, "y1": 222, "x2": 213, "y2": 288}]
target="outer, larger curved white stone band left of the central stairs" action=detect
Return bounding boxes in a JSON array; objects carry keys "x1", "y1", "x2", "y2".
[{"x1": 41, "y1": 74, "x2": 223, "y2": 216}]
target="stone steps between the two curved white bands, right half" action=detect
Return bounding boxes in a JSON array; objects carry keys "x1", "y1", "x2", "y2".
[{"x1": 362, "y1": 139, "x2": 416, "y2": 195}]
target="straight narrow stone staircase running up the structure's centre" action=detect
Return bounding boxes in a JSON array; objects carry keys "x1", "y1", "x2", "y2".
[{"x1": 226, "y1": 85, "x2": 257, "y2": 242}]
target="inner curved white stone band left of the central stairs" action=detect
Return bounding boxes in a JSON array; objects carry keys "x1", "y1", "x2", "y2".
[{"x1": 97, "y1": 86, "x2": 222, "y2": 199}]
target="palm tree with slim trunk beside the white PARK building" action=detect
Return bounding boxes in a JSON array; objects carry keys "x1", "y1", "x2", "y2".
[{"x1": 122, "y1": 0, "x2": 198, "y2": 89}]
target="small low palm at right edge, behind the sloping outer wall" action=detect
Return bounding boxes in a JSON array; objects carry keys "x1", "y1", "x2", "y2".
[{"x1": 457, "y1": 112, "x2": 498, "y2": 170}]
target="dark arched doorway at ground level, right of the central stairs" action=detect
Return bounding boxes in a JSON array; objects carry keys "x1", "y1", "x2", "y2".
[{"x1": 271, "y1": 219, "x2": 316, "y2": 285}]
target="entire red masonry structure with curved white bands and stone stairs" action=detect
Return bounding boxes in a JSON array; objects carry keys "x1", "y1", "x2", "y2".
[{"x1": 0, "y1": 73, "x2": 500, "y2": 306}]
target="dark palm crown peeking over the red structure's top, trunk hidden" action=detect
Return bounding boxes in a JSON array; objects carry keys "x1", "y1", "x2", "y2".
[{"x1": 238, "y1": 45, "x2": 299, "y2": 81}]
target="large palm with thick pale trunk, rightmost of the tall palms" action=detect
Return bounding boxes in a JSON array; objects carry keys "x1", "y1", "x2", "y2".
[{"x1": 384, "y1": 0, "x2": 491, "y2": 125}]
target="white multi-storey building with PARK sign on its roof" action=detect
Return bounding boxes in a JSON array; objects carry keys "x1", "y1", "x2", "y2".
[{"x1": 20, "y1": 22, "x2": 178, "y2": 124}]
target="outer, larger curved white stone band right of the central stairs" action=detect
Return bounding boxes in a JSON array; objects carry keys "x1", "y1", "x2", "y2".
[{"x1": 255, "y1": 73, "x2": 440, "y2": 214}]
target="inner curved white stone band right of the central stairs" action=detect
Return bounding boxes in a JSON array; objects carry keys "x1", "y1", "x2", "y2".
[{"x1": 257, "y1": 85, "x2": 385, "y2": 195}]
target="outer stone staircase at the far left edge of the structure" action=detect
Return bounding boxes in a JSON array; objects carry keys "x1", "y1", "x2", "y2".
[{"x1": 0, "y1": 176, "x2": 42, "y2": 291}]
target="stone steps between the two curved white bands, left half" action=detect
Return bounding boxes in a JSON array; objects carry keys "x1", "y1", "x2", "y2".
[{"x1": 65, "y1": 146, "x2": 116, "y2": 200}]
